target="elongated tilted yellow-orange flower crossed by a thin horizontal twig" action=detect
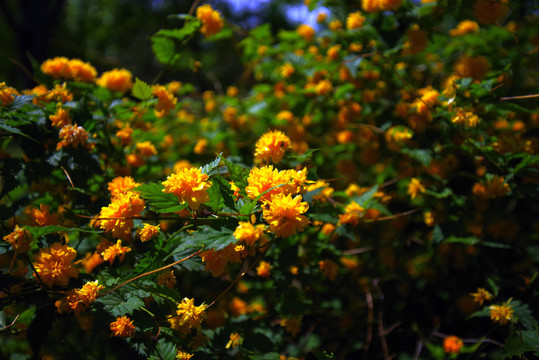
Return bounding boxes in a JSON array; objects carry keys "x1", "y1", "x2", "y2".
[{"x1": 99, "y1": 191, "x2": 145, "y2": 240}]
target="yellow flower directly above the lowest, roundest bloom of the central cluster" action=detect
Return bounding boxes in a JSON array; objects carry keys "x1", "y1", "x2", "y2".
[{"x1": 245, "y1": 165, "x2": 294, "y2": 202}]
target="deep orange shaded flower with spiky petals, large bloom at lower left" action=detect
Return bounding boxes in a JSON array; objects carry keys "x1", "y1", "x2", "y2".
[{"x1": 33, "y1": 242, "x2": 79, "y2": 287}]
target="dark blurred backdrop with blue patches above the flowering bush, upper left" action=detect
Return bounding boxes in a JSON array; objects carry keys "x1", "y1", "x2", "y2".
[{"x1": 0, "y1": 0, "x2": 330, "y2": 89}]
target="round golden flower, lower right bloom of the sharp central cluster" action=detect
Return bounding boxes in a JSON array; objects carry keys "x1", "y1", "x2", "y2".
[{"x1": 262, "y1": 194, "x2": 309, "y2": 237}]
